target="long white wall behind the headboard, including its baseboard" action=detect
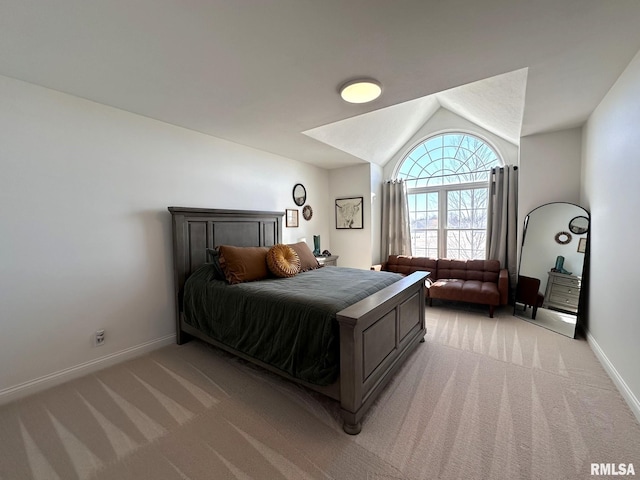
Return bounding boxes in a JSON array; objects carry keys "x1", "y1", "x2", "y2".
[{"x1": 0, "y1": 76, "x2": 330, "y2": 402}]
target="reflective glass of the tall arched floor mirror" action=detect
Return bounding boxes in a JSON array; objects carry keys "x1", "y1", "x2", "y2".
[{"x1": 513, "y1": 202, "x2": 589, "y2": 338}]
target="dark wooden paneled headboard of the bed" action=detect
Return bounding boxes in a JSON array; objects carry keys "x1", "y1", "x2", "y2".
[{"x1": 169, "y1": 207, "x2": 284, "y2": 343}]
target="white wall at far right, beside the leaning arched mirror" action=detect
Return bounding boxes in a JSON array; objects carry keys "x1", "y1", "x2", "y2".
[{"x1": 583, "y1": 47, "x2": 640, "y2": 420}]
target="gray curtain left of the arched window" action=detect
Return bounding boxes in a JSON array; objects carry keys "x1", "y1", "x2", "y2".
[{"x1": 381, "y1": 180, "x2": 411, "y2": 262}]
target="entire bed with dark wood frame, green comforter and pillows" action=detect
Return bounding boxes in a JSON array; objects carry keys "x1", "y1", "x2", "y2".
[{"x1": 169, "y1": 207, "x2": 426, "y2": 435}]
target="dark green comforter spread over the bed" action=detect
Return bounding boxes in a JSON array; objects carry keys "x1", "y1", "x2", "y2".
[{"x1": 184, "y1": 264, "x2": 402, "y2": 385}]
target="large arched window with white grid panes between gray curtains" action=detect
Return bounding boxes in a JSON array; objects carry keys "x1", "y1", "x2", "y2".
[{"x1": 395, "y1": 133, "x2": 503, "y2": 259}]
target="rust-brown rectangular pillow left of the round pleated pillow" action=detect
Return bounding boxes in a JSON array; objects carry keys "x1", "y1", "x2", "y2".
[{"x1": 218, "y1": 245, "x2": 269, "y2": 284}]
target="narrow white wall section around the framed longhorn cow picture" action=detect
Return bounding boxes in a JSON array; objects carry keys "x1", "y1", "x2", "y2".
[{"x1": 322, "y1": 163, "x2": 372, "y2": 270}]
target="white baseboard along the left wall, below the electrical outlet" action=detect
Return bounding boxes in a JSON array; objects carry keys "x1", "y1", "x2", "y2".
[{"x1": 0, "y1": 334, "x2": 176, "y2": 405}]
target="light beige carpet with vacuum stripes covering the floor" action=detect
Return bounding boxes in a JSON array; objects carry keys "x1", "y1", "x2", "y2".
[{"x1": 0, "y1": 305, "x2": 640, "y2": 480}]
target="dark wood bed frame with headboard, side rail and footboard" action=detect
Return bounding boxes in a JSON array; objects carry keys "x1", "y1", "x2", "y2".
[{"x1": 169, "y1": 207, "x2": 427, "y2": 435}]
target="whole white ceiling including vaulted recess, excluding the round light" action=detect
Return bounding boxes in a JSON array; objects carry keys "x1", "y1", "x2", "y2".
[{"x1": 0, "y1": 0, "x2": 640, "y2": 168}]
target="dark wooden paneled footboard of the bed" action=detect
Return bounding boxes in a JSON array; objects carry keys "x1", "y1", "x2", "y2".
[{"x1": 337, "y1": 272, "x2": 428, "y2": 435}]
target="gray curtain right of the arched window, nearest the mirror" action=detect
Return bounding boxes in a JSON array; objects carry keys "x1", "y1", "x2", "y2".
[{"x1": 487, "y1": 165, "x2": 518, "y2": 289}]
